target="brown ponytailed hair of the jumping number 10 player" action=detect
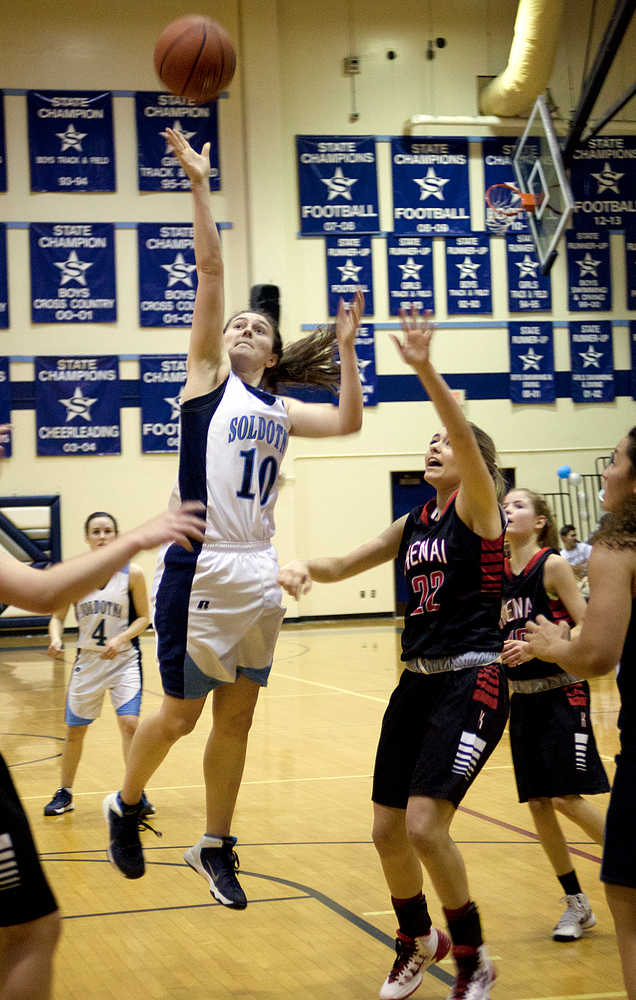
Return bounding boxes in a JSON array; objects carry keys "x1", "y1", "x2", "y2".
[{"x1": 223, "y1": 309, "x2": 340, "y2": 393}]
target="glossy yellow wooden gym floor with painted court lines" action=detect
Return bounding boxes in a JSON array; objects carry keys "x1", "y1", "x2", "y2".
[{"x1": 0, "y1": 619, "x2": 625, "y2": 1000}]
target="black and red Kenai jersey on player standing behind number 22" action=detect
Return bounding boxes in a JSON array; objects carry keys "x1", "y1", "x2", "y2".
[{"x1": 501, "y1": 548, "x2": 574, "y2": 681}]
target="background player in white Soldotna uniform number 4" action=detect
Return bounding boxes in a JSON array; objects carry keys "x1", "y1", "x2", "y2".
[{"x1": 44, "y1": 511, "x2": 154, "y2": 816}]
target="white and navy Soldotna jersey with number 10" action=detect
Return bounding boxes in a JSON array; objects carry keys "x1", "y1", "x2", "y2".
[{"x1": 173, "y1": 372, "x2": 290, "y2": 543}]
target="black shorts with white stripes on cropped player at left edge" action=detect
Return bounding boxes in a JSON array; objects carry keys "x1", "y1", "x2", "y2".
[{"x1": 0, "y1": 754, "x2": 57, "y2": 927}]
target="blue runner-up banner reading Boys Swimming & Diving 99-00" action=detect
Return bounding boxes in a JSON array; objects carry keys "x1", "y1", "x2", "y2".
[{"x1": 565, "y1": 229, "x2": 612, "y2": 312}]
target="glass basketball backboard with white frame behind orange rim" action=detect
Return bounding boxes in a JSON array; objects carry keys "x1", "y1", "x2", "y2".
[{"x1": 512, "y1": 96, "x2": 574, "y2": 274}]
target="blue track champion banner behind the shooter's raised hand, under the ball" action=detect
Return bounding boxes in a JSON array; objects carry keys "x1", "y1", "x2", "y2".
[{"x1": 135, "y1": 91, "x2": 221, "y2": 191}]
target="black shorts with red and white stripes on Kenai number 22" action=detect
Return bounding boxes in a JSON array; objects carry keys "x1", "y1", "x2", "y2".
[{"x1": 372, "y1": 663, "x2": 508, "y2": 809}]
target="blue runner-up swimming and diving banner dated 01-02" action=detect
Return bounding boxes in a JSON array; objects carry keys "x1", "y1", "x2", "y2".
[{"x1": 569, "y1": 320, "x2": 615, "y2": 403}]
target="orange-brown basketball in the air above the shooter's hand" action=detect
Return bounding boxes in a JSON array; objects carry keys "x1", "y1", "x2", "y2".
[{"x1": 154, "y1": 14, "x2": 236, "y2": 104}]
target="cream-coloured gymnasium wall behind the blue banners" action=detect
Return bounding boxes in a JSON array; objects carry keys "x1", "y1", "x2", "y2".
[{"x1": 0, "y1": 0, "x2": 636, "y2": 616}]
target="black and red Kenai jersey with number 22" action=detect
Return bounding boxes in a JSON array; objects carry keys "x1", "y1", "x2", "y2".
[{"x1": 398, "y1": 493, "x2": 503, "y2": 660}]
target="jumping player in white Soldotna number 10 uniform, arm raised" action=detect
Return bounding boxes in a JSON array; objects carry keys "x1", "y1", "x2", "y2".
[{"x1": 104, "y1": 129, "x2": 364, "y2": 909}]
